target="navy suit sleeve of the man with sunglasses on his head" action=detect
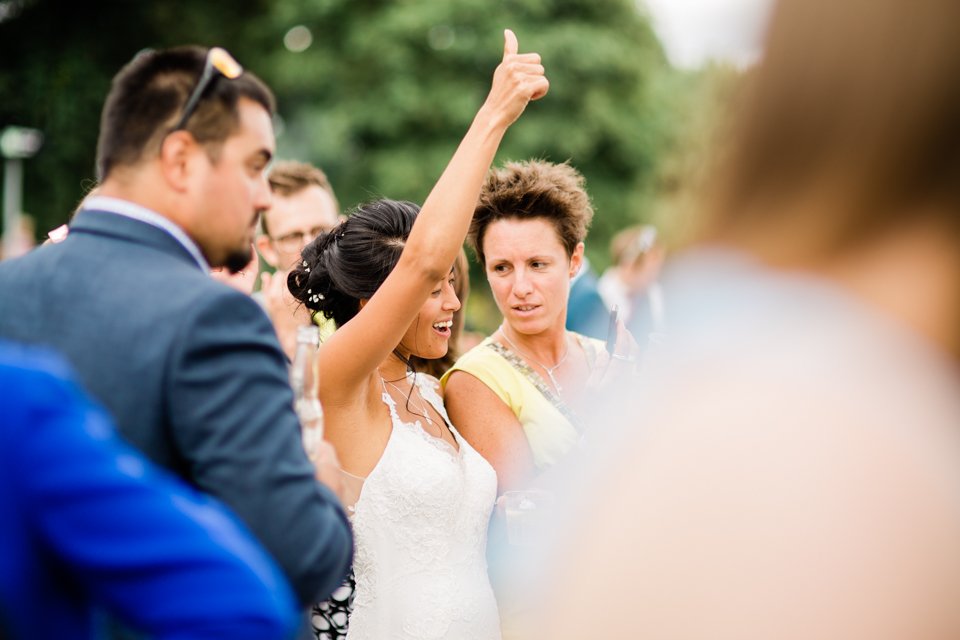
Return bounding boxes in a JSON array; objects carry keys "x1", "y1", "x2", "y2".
[{"x1": 164, "y1": 287, "x2": 353, "y2": 605}]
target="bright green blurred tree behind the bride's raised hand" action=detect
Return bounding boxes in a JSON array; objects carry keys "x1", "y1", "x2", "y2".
[{"x1": 263, "y1": 0, "x2": 671, "y2": 263}]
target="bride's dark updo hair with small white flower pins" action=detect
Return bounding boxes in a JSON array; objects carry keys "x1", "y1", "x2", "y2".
[{"x1": 287, "y1": 199, "x2": 420, "y2": 327}]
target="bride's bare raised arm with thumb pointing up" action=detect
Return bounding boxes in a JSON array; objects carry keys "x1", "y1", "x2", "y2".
[{"x1": 319, "y1": 29, "x2": 549, "y2": 397}]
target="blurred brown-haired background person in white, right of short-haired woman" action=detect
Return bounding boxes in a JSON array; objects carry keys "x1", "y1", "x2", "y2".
[{"x1": 597, "y1": 224, "x2": 666, "y2": 342}]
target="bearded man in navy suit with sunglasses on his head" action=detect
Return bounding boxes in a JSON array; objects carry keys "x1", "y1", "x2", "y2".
[{"x1": 0, "y1": 47, "x2": 352, "y2": 616}]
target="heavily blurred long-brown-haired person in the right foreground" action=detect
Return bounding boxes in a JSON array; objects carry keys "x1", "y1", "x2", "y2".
[{"x1": 541, "y1": 0, "x2": 960, "y2": 640}]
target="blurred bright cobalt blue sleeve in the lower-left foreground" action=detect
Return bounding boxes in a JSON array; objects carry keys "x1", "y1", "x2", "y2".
[{"x1": 0, "y1": 350, "x2": 299, "y2": 640}]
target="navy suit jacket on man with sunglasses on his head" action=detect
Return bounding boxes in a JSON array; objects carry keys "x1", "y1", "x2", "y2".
[{"x1": 0, "y1": 211, "x2": 353, "y2": 604}]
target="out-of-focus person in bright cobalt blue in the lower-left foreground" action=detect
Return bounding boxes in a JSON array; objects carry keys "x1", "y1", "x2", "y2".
[{"x1": 0, "y1": 342, "x2": 299, "y2": 640}]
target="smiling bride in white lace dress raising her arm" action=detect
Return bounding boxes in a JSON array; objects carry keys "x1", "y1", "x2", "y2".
[{"x1": 288, "y1": 30, "x2": 549, "y2": 640}]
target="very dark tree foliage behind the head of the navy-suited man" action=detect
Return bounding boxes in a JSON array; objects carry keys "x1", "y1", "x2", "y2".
[{"x1": 0, "y1": 0, "x2": 271, "y2": 233}]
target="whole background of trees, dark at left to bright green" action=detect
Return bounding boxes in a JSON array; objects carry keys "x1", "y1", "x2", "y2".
[{"x1": 0, "y1": 0, "x2": 695, "y2": 325}]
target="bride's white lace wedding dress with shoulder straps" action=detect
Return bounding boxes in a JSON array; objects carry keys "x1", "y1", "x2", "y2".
[{"x1": 347, "y1": 374, "x2": 500, "y2": 640}]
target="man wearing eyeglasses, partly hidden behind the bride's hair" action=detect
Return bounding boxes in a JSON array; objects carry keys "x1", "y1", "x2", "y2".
[{"x1": 254, "y1": 160, "x2": 340, "y2": 360}]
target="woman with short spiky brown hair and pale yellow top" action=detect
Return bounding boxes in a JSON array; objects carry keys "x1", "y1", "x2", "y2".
[{"x1": 442, "y1": 160, "x2": 635, "y2": 492}]
